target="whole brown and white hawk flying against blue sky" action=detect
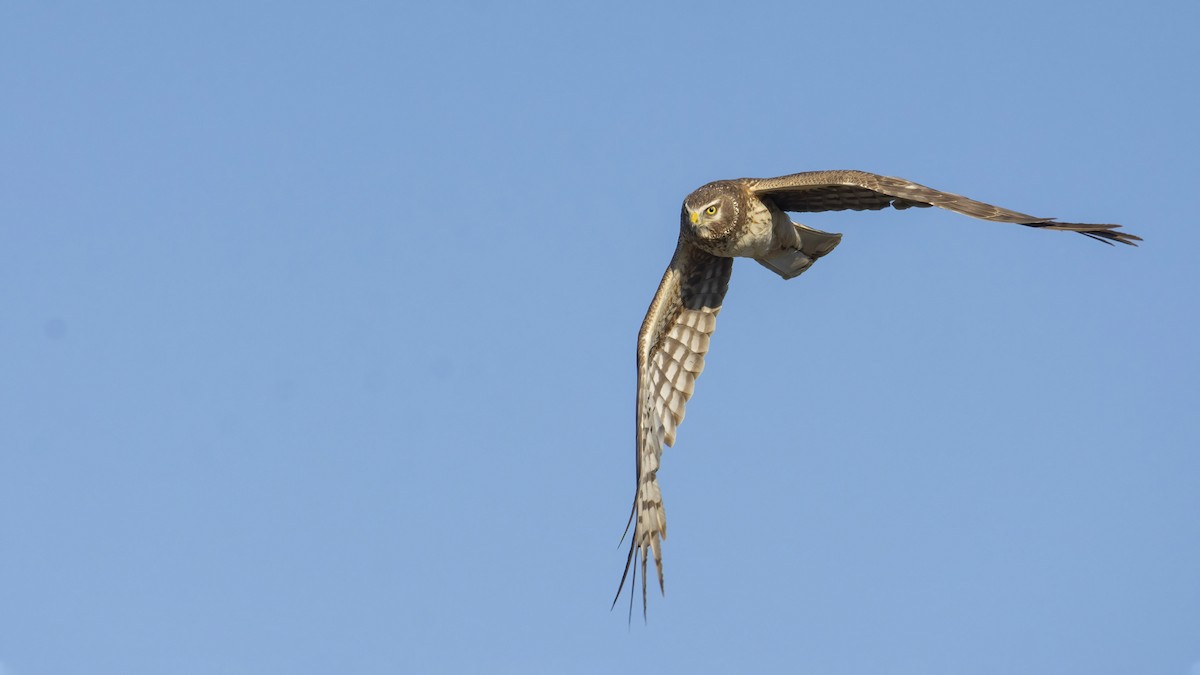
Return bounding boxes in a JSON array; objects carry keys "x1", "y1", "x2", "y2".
[{"x1": 613, "y1": 171, "x2": 1141, "y2": 615}]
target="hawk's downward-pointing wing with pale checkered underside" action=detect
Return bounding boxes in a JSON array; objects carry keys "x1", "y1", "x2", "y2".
[{"x1": 612, "y1": 238, "x2": 733, "y2": 616}]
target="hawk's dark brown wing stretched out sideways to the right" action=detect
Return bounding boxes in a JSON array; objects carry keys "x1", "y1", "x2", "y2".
[{"x1": 746, "y1": 171, "x2": 1141, "y2": 246}]
